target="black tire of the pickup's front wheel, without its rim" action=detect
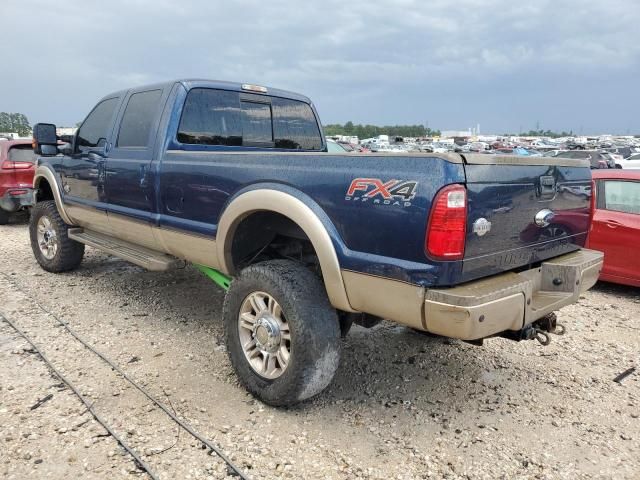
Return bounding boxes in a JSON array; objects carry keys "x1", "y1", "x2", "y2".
[{"x1": 29, "y1": 200, "x2": 84, "y2": 273}]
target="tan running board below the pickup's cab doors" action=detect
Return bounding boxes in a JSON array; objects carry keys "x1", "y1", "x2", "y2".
[{"x1": 68, "y1": 228, "x2": 185, "y2": 272}]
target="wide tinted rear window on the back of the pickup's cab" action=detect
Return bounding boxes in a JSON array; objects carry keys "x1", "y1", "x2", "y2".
[{"x1": 177, "y1": 88, "x2": 322, "y2": 150}]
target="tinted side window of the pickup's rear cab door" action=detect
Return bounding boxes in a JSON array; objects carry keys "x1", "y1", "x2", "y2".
[{"x1": 117, "y1": 90, "x2": 162, "y2": 147}]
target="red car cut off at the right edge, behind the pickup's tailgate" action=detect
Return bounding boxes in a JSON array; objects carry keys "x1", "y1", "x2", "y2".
[{"x1": 586, "y1": 169, "x2": 640, "y2": 287}]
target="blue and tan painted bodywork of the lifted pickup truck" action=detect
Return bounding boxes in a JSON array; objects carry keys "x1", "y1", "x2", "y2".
[{"x1": 35, "y1": 80, "x2": 590, "y2": 326}]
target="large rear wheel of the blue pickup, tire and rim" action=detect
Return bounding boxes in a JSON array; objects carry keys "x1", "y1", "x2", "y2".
[{"x1": 223, "y1": 260, "x2": 340, "y2": 406}]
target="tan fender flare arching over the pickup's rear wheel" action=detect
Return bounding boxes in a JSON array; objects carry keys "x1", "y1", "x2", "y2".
[{"x1": 216, "y1": 185, "x2": 354, "y2": 312}]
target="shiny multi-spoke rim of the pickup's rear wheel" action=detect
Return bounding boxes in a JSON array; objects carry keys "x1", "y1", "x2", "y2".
[{"x1": 238, "y1": 292, "x2": 291, "y2": 380}]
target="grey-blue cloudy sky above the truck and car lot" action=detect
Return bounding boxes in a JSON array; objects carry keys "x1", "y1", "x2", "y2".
[{"x1": 0, "y1": 0, "x2": 640, "y2": 134}]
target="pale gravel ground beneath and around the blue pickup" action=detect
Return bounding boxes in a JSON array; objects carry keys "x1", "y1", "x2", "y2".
[{"x1": 0, "y1": 216, "x2": 640, "y2": 480}]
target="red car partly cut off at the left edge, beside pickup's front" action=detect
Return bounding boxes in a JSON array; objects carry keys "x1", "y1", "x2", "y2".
[{"x1": 0, "y1": 140, "x2": 36, "y2": 225}]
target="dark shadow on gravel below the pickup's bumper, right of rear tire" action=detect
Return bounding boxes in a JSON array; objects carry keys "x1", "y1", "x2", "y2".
[{"x1": 314, "y1": 322, "x2": 502, "y2": 410}]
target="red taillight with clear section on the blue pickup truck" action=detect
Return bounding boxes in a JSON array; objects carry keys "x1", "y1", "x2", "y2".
[{"x1": 424, "y1": 185, "x2": 467, "y2": 260}]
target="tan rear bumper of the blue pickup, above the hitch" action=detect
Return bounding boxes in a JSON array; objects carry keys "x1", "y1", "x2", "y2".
[{"x1": 424, "y1": 249, "x2": 604, "y2": 340}]
